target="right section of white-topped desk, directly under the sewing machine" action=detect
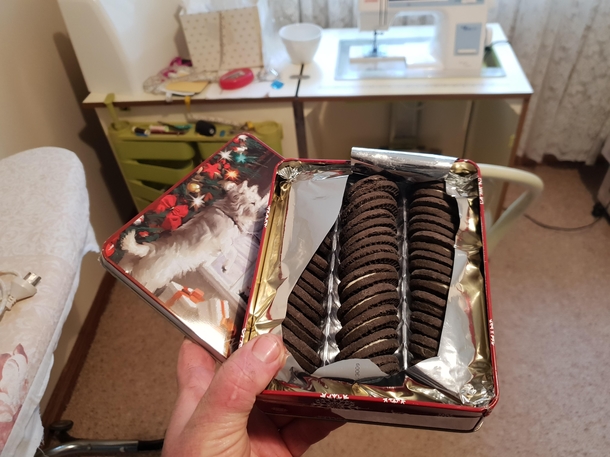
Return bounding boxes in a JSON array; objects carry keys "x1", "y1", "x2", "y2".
[{"x1": 295, "y1": 24, "x2": 533, "y2": 186}]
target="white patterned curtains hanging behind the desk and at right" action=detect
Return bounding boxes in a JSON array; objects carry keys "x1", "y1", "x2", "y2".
[{"x1": 267, "y1": 0, "x2": 610, "y2": 163}]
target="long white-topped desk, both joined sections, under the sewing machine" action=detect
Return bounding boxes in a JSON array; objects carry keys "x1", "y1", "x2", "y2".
[{"x1": 83, "y1": 24, "x2": 533, "y2": 216}]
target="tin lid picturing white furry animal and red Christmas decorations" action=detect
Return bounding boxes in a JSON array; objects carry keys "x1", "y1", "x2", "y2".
[{"x1": 100, "y1": 133, "x2": 283, "y2": 361}]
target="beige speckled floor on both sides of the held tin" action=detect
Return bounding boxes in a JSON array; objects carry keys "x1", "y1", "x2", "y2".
[{"x1": 57, "y1": 163, "x2": 610, "y2": 457}]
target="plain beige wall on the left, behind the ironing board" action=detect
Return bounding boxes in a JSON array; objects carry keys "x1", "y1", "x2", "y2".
[{"x1": 0, "y1": 0, "x2": 126, "y2": 407}]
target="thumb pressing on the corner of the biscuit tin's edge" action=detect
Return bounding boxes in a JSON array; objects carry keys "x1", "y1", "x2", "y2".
[{"x1": 193, "y1": 334, "x2": 286, "y2": 438}]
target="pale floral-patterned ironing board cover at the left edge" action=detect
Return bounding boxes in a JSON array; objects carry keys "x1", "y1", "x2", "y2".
[{"x1": 0, "y1": 148, "x2": 98, "y2": 457}]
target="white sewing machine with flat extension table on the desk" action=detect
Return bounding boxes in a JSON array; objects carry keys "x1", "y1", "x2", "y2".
[{"x1": 336, "y1": 0, "x2": 497, "y2": 79}]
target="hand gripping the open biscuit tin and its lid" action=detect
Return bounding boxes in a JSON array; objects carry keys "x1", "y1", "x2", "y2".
[{"x1": 163, "y1": 334, "x2": 342, "y2": 457}]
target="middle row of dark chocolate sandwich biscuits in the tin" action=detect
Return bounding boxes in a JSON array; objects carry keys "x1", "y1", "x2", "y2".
[{"x1": 335, "y1": 175, "x2": 400, "y2": 374}]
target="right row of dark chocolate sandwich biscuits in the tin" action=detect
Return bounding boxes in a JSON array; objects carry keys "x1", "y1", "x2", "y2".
[{"x1": 407, "y1": 183, "x2": 459, "y2": 365}]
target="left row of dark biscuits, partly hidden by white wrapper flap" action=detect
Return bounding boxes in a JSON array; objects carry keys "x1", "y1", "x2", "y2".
[{"x1": 282, "y1": 234, "x2": 332, "y2": 373}]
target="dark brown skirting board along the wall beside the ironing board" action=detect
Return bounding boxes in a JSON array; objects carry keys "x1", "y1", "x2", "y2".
[{"x1": 42, "y1": 273, "x2": 116, "y2": 433}]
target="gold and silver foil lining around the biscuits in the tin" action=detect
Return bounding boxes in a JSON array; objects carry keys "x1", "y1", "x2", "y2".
[{"x1": 244, "y1": 148, "x2": 495, "y2": 407}]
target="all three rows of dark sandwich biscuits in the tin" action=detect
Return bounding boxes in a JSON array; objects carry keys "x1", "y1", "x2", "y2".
[{"x1": 282, "y1": 175, "x2": 459, "y2": 374}]
